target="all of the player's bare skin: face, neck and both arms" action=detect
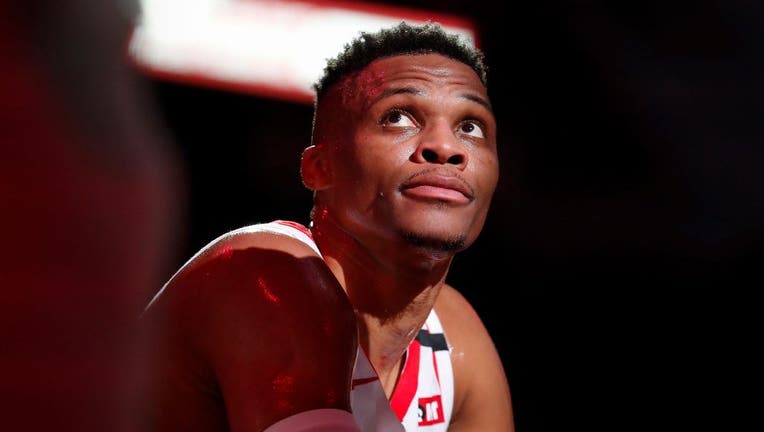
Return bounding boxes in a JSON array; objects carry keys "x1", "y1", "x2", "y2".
[{"x1": 140, "y1": 54, "x2": 513, "y2": 432}]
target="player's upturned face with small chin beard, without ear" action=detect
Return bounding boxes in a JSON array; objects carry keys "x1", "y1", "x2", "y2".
[{"x1": 319, "y1": 54, "x2": 499, "y2": 251}]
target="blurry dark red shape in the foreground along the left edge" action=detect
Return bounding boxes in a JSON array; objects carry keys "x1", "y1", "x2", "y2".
[{"x1": 0, "y1": 0, "x2": 182, "y2": 431}]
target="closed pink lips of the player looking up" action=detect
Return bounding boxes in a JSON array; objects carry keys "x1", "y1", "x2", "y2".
[{"x1": 401, "y1": 172, "x2": 475, "y2": 204}]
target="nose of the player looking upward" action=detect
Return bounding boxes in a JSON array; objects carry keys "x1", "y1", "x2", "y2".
[{"x1": 413, "y1": 122, "x2": 467, "y2": 167}]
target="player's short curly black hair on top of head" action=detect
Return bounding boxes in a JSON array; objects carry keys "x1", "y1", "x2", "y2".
[{"x1": 313, "y1": 21, "x2": 488, "y2": 101}]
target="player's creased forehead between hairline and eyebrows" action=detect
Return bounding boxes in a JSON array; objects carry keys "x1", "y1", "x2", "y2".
[{"x1": 350, "y1": 54, "x2": 486, "y2": 98}]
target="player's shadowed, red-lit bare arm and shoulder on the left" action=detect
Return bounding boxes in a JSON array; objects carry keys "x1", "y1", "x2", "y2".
[{"x1": 144, "y1": 233, "x2": 357, "y2": 432}]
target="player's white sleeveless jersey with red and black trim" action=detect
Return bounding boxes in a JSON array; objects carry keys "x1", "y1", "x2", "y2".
[{"x1": 260, "y1": 221, "x2": 454, "y2": 432}]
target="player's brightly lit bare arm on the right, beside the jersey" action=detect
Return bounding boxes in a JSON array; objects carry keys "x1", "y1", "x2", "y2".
[{"x1": 435, "y1": 286, "x2": 514, "y2": 432}]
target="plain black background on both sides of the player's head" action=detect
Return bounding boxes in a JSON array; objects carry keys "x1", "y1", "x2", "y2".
[{"x1": 140, "y1": 0, "x2": 764, "y2": 432}]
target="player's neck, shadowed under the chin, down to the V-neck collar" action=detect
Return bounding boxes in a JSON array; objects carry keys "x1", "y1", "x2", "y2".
[{"x1": 311, "y1": 209, "x2": 452, "y2": 396}]
